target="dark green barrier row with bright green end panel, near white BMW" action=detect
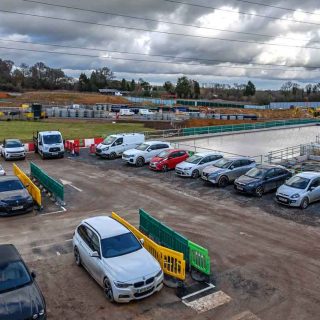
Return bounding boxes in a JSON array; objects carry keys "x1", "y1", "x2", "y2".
[{"x1": 139, "y1": 209, "x2": 211, "y2": 275}]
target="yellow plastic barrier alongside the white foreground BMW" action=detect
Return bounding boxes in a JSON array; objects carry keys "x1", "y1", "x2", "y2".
[{"x1": 112, "y1": 212, "x2": 186, "y2": 280}]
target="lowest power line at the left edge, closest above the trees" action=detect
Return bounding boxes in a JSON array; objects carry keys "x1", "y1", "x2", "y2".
[{"x1": 0, "y1": 46, "x2": 317, "y2": 72}]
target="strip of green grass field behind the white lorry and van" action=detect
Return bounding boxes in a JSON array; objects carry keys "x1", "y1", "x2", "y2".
[{"x1": 0, "y1": 121, "x2": 150, "y2": 142}]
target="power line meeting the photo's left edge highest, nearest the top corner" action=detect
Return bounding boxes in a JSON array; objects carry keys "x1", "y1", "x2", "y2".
[{"x1": 0, "y1": 8, "x2": 320, "y2": 50}]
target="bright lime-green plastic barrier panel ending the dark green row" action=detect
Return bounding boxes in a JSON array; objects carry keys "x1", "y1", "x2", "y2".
[{"x1": 188, "y1": 241, "x2": 211, "y2": 275}]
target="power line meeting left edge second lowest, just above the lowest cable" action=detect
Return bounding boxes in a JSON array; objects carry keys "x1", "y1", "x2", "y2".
[{"x1": 0, "y1": 38, "x2": 320, "y2": 71}]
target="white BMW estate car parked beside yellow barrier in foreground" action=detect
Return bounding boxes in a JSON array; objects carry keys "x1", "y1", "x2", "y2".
[{"x1": 73, "y1": 216, "x2": 163, "y2": 302}]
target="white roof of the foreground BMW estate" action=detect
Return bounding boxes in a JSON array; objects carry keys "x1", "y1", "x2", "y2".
[{"x1": 82, "y1": 216, "x2": 130, "y2": 239}]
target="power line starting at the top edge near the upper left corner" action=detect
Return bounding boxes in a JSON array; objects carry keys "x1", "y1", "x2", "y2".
[{"x1": 21, "y1": 0, "x2": 308, "y2": 42}]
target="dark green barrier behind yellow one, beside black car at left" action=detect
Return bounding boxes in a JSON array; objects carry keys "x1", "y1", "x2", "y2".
[{"x1": 30, "y1": 162, "x2": 64, "y2": 201}]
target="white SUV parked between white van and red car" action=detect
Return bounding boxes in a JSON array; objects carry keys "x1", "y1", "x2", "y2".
[{"x1": 122, "y1": 141, "x2": 171, "y2": 167}]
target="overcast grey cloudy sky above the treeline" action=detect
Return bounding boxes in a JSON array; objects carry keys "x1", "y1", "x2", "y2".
[{"x1": 0, "y1": 0, "x2": 320, "y2": 88}]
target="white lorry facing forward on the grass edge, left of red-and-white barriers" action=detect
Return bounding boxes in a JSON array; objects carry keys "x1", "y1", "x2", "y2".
[{"x1": 33, "y1": 131, "x2": 64, "y2": 159}]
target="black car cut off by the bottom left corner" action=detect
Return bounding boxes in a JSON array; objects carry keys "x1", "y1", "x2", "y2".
[{"x1": 0, "y1": 244, "x2": 47, "y2": 320}]
